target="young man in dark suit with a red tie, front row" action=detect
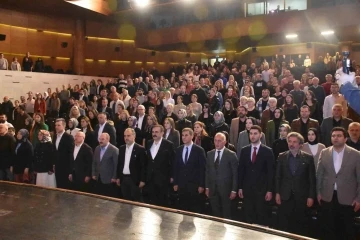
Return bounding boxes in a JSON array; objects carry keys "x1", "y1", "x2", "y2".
[{"x1": 239, "y1": 125, "x2": 275, "y2": 226}]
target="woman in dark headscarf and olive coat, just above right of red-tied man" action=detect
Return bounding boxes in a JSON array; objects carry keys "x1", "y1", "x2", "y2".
[{"x1": 265, "y1": 108, "x2": 289, "y2": 147}]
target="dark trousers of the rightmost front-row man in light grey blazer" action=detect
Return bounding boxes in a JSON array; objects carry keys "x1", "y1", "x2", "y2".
[{"x1": 321, "y1": 191, "x2": 355, "y2": 240}]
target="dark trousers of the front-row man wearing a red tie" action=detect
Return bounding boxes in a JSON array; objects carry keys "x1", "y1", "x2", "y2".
[{"x1": 243, "y1": 190, "x2": 270, "y2": 226}]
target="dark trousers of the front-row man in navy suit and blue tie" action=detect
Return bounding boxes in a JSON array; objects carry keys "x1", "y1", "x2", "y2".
[{"x1": 178, "y1": 183, "x2": 204, "y2": 213}]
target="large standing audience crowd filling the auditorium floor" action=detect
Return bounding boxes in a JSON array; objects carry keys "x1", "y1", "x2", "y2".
[{"x1": 0, "y1": 58, "x2": 360, "y2": 239}]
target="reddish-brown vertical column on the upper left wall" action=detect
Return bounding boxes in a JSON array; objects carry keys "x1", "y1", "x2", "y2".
[{"x1": 73, "y1": 19, "x2": 85, "y2": 75}]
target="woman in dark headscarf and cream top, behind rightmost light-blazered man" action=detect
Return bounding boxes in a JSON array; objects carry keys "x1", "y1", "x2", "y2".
[{"x1": 301, "y1": 128, "x2": 326, "y2": 169}]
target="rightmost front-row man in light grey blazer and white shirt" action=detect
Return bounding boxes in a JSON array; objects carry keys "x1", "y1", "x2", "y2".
[{"x1": 316, "y1": 127, "x2": 360, "y2": 240}]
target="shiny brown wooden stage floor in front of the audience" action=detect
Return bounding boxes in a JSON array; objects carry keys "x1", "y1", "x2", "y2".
[{"x1": 0, "y1": 181, "x2": 308, "y2": 240}]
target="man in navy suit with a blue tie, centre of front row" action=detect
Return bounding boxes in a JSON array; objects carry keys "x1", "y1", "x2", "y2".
[{"x1": 173, "y1": 128, "x2": 206, "y2": 213}]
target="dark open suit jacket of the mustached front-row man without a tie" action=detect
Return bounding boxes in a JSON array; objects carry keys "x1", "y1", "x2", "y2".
[{"x1": 146, "y1": 138, "x2": 175, "y2": 186}]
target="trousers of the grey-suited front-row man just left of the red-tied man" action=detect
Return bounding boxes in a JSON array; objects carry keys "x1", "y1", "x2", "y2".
[{"x1": 209, "y1": 189, "x2": 231, "y2": 219}]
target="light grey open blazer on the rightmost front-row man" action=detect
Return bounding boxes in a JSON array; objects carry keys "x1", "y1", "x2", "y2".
[{"x1": 316, "y1": 145, "x2": 360, "y2": 205}]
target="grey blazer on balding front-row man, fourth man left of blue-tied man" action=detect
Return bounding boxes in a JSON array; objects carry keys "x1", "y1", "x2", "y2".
[{"x1": 92, "y1": 143, "x2": 119, "y2": 184}]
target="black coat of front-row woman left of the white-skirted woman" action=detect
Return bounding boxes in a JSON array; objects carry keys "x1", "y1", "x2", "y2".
[{"x1": 12, "y1": 141, "x2": 34, "y2": 174}]
